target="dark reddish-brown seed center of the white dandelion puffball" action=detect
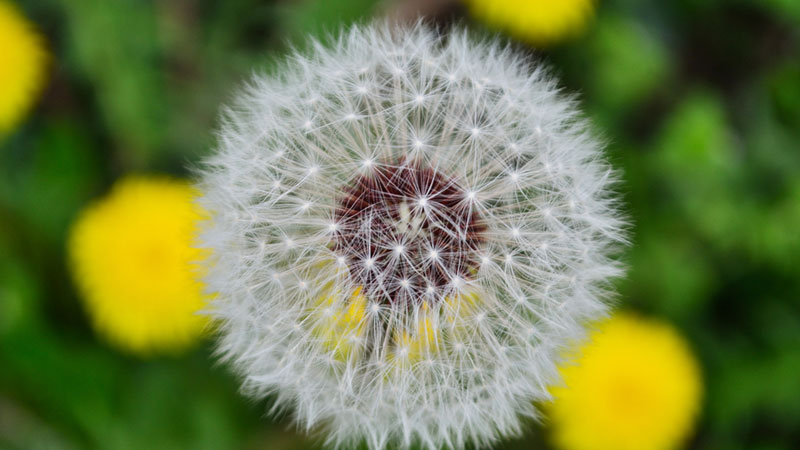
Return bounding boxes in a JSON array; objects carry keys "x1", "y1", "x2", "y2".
[{"x1": 334, "y1": 161, "x2": 486, "y2": 303}]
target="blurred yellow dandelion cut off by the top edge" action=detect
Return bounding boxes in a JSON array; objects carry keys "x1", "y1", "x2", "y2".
[{"x1": 465, "y1": 0, "x2": 594, "y2": 46}]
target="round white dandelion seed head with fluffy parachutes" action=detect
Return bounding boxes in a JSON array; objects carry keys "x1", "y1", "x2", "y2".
[{"x1": 201, "y1": 24, "x2": 624, "y2": 449}]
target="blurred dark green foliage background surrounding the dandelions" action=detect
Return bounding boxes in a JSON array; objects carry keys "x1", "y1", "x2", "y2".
[{"x1": 0, "y1": 0, "x2": 800, "y2": 450}]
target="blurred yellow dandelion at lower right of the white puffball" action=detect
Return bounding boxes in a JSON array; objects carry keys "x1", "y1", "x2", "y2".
[{"x1": 547, "y1": 313, "x2": 702, "y2": 450}]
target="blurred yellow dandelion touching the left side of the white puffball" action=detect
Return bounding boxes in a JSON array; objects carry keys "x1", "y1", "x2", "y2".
[{"x1": 68, "y1": 177, "x2": 207, "y2": 355}]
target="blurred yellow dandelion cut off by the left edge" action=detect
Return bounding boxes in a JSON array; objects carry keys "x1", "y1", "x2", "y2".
[{"x1": 0, "y1": 0, "x2": 47, "y2": 136}]
